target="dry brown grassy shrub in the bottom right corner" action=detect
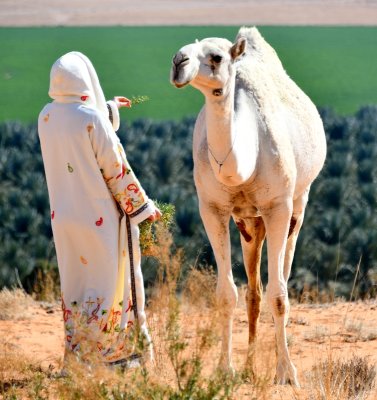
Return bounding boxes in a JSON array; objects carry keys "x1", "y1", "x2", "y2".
[{"x1": 311, "y1": 354, "x2": 376, "y2": 400}]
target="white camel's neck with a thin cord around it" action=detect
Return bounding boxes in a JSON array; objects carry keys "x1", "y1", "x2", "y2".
[{"x1": 206, "y1": 72, "x2": 258, "y2": 186}]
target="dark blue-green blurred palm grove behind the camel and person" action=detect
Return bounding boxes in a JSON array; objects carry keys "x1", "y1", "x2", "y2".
[{"x1": 0, "y1": 106, "x2": 377, "y2": 297}]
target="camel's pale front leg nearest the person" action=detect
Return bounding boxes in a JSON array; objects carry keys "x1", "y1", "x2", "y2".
[{"x1": 199, "y1": 201, "x2": 237, "y2": 373}]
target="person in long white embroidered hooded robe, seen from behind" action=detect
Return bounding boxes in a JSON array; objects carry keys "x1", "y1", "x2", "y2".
[{"x1": 38, "y1": 52, "x2": 157, "y2": 365}]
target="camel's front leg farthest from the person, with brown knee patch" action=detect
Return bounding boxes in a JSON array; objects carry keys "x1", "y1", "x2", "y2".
[{"x1": 262, "y1": 199, "x2": 298, "y2": 386}]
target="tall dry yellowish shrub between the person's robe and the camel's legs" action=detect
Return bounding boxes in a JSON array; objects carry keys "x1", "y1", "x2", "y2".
[{"x1": 139, "y1": 226, "x2": 236, "y2": 399}]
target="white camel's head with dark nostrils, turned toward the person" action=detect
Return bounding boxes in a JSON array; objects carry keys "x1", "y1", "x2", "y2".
[{"x1": 170, "y1": 38, "x2": 246, "y2": 96}]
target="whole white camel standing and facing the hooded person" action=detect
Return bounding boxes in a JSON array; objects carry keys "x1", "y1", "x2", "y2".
[{"x1": 170, "y1": 27, "x2": 326, "y2": 386}]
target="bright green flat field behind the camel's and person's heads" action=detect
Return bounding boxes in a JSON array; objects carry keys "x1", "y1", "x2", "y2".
[{"x1": 0, "y1": 27, "x2": 377, "y2": 122}]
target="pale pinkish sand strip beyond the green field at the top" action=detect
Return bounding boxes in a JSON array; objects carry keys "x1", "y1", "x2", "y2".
[{"x1": 0, "y1": 0, "x2": 377, "y2": 26}]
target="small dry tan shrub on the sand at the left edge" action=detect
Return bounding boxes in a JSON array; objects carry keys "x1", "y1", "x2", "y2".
[{"x1": 0, "y1": 288, "x2": 33, "y2": 321}]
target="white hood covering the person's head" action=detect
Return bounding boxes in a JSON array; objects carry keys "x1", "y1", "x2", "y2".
[{"x1": 48, "y1": 51, "x2": 108, "y2": 118}]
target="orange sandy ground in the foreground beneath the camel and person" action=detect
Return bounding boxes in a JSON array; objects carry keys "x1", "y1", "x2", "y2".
[{"x1": 0, "y1": 301, "x2": 377, "y2": 400}]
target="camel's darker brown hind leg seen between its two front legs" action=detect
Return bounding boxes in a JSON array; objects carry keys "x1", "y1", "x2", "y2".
[{"x1": 236, "y1": 217, "x2": 266, "y2": 370}]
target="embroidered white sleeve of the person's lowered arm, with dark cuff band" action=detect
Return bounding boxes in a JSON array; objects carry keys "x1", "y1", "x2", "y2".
[{"x1": 91, "y1": 114, "x2": 155, "y2": 224}]
